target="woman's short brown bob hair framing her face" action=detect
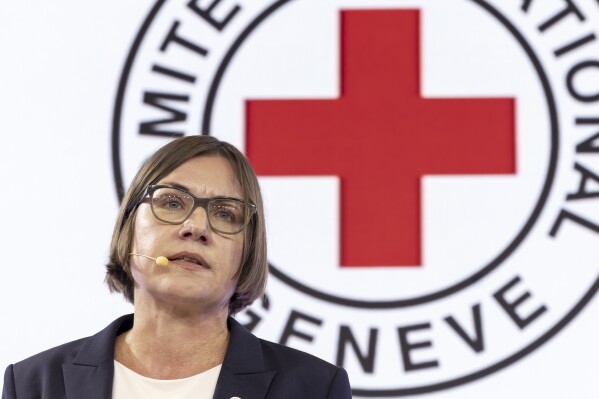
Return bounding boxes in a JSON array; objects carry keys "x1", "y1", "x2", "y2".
[{"x1": 106, "y1": 136, "x2": 268, "y2": 314}]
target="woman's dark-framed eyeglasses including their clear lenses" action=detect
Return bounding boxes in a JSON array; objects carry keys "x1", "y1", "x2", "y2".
[{"x1": 142, "y1": 184, "x2": 256, "y2": 234}]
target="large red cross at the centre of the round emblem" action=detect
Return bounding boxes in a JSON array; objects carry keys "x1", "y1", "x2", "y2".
[{"x1": 246, "y1": 10, "x2": 515, "y2": 266}]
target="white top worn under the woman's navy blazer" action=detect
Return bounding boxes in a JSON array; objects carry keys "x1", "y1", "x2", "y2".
[{"x1": 112, "y1": 360, "x2": 222, "y2": 399}]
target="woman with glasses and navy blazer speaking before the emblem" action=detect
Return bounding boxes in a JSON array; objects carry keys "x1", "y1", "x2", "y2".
[{"x1": 2, "y1": 136, "x2": 351, "y2": 399}]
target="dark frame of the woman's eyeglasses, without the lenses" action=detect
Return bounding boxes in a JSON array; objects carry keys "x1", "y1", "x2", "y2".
[{"x1": 132, "y1": 184, "x2": 257, "y2": 235}]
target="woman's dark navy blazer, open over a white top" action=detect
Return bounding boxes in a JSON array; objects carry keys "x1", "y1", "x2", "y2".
[{"x1": 2, "y1": 315, "x2": 351, "y2": 399}]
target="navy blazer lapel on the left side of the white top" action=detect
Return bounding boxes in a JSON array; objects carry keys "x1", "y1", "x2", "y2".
[{"x1": 62, "y1": 315, "x2": 134, "y2": 399}]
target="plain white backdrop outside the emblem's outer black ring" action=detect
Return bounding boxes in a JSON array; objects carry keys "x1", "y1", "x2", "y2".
[{"x1": 0, "y1": 0, "x2": 599, "y2": 399}]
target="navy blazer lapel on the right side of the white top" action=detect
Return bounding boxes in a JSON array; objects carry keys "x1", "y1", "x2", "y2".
[{"x1": 214, "y1": 318, "x2": 277, "y2": 399}]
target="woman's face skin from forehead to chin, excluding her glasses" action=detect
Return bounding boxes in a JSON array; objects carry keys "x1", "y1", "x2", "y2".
[{"x1": 130, "y1": 155, "x2": 244, "y2": 312}]
